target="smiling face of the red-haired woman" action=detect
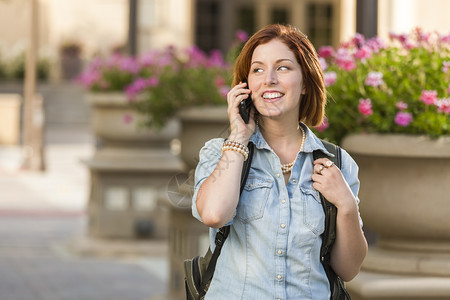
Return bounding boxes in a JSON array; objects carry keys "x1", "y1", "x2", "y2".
[{"x1": 248, "y1": 39, "x2": 303, "y2": 118}]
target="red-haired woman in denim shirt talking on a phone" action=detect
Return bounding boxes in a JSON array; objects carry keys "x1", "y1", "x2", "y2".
[{"x1": 192, "y1": 25, "x2": 367, "y2": 300}]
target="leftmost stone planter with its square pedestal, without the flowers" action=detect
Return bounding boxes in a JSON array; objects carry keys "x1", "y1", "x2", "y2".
[{"x1": 85, "y1": 93, "x2": 185, "y2": 238}]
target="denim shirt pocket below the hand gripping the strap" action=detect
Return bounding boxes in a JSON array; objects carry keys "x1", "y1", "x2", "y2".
[{"x1": 300, "y1": 187, "x2": 325, "y2": 235}]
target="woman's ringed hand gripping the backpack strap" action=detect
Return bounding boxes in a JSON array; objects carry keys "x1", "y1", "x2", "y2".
[{"x1": 312, "y1": 158, "x2": 356, "y2": 209}]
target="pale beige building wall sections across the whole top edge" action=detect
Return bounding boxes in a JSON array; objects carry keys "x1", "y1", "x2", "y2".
[{"x1": 0, "y1": 0, "x2": 450, "y2": 62}]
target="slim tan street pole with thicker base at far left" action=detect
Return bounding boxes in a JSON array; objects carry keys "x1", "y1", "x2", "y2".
[{"x1": 22, "y1": 0, "x2": 45, "y2": 171}]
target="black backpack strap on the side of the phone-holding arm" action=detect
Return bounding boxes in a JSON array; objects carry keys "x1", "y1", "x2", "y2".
[{"x1": 200, "y1": 142, "x2": 254, "y2": 296}]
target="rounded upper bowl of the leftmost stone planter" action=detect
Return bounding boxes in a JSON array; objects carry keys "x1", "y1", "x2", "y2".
[{"x1": 86, "y1": 93, "x2": 179, "y2": 146}]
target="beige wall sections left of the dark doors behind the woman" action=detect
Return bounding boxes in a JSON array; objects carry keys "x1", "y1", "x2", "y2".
[{"x1": 0, "y1": 0, "x2": 194, "y2": 58}]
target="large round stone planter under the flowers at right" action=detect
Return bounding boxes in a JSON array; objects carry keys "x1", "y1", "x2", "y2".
[{"x1": 342, "y1": 134, "x2": 450, "y2": 300}]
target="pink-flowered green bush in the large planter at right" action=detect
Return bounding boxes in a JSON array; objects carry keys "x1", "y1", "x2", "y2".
[{"x1": 318, "y1": 29, "x2": 450, "y2": 142}]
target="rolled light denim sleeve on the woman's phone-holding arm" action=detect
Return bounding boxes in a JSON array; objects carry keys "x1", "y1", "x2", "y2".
[{"x1": 192, "y1": 138, "x2": 224, "y2": 222}]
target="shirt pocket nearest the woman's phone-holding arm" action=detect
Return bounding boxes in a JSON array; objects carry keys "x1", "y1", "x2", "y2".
[{"x1": 236, "y1": 176, "x2": 273, "y2": 223}]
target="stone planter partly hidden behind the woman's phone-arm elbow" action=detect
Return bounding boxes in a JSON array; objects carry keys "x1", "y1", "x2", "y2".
[{"x1": 161, "y1": 106, "x2": 229, "y2": 299}]
